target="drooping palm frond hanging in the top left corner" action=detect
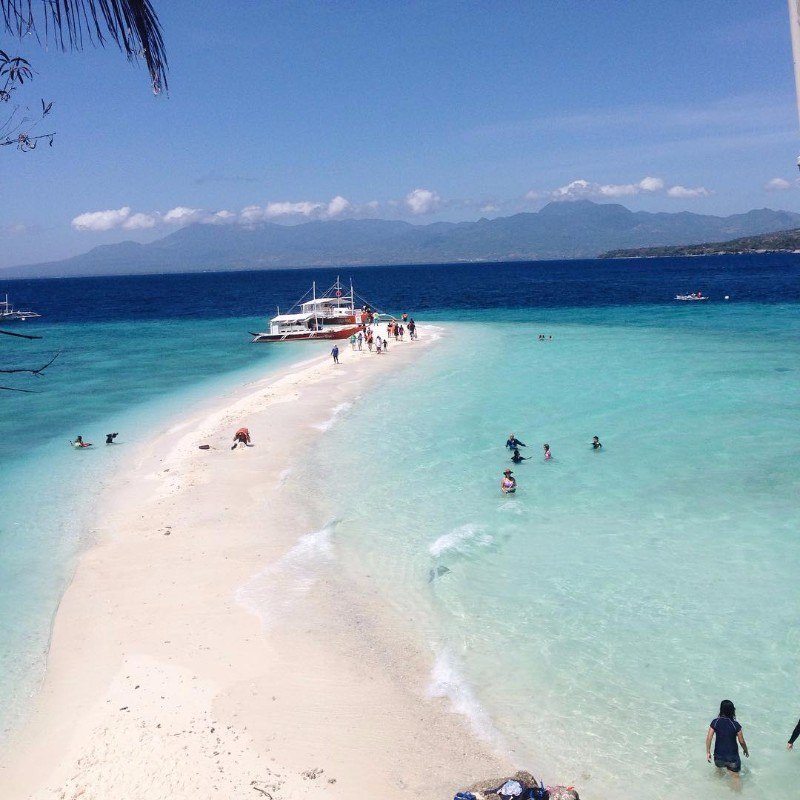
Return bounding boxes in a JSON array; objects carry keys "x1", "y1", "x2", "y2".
[{"x1": 0, "y1": 0, "x2": 167, "y2": 94}]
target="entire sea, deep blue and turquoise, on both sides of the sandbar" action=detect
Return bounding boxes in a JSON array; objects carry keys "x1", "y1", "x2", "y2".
[{"x1": 0, "y1": 255, "x2": 800, "y2": 800}]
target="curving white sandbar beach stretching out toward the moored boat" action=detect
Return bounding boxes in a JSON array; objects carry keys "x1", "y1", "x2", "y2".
[{"x1": 0, "y1": 324, "x2": 513, "y2": 800}]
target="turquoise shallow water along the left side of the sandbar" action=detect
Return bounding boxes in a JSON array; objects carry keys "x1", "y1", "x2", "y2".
[{"x1": 0, "y1": 318, "x2": 324, "y2": 738}]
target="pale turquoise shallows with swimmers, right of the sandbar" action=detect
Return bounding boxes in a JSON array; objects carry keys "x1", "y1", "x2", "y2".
[{"x1": 305, "y1": 304, "x2": 800, "y2": 798}]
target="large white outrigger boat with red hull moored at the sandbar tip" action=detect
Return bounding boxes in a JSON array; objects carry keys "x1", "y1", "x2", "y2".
[{"x1": 250, "y1": 278, "x2": 378, "y2": 342}]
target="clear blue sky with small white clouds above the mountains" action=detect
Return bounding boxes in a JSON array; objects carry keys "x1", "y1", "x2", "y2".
[{"x1": 0, "y1": 0, "x2": 800, "y2": 267}]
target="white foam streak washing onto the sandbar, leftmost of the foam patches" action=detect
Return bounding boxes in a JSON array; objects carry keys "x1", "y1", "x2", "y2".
[{"x1": 235, "y1": 520, "x2": 336, "y2": 628}]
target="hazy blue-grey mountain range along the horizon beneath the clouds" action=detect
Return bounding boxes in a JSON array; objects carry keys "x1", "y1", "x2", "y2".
[{"x1": 6, "y1": 200, "x2": 800, "y2": 278}]
